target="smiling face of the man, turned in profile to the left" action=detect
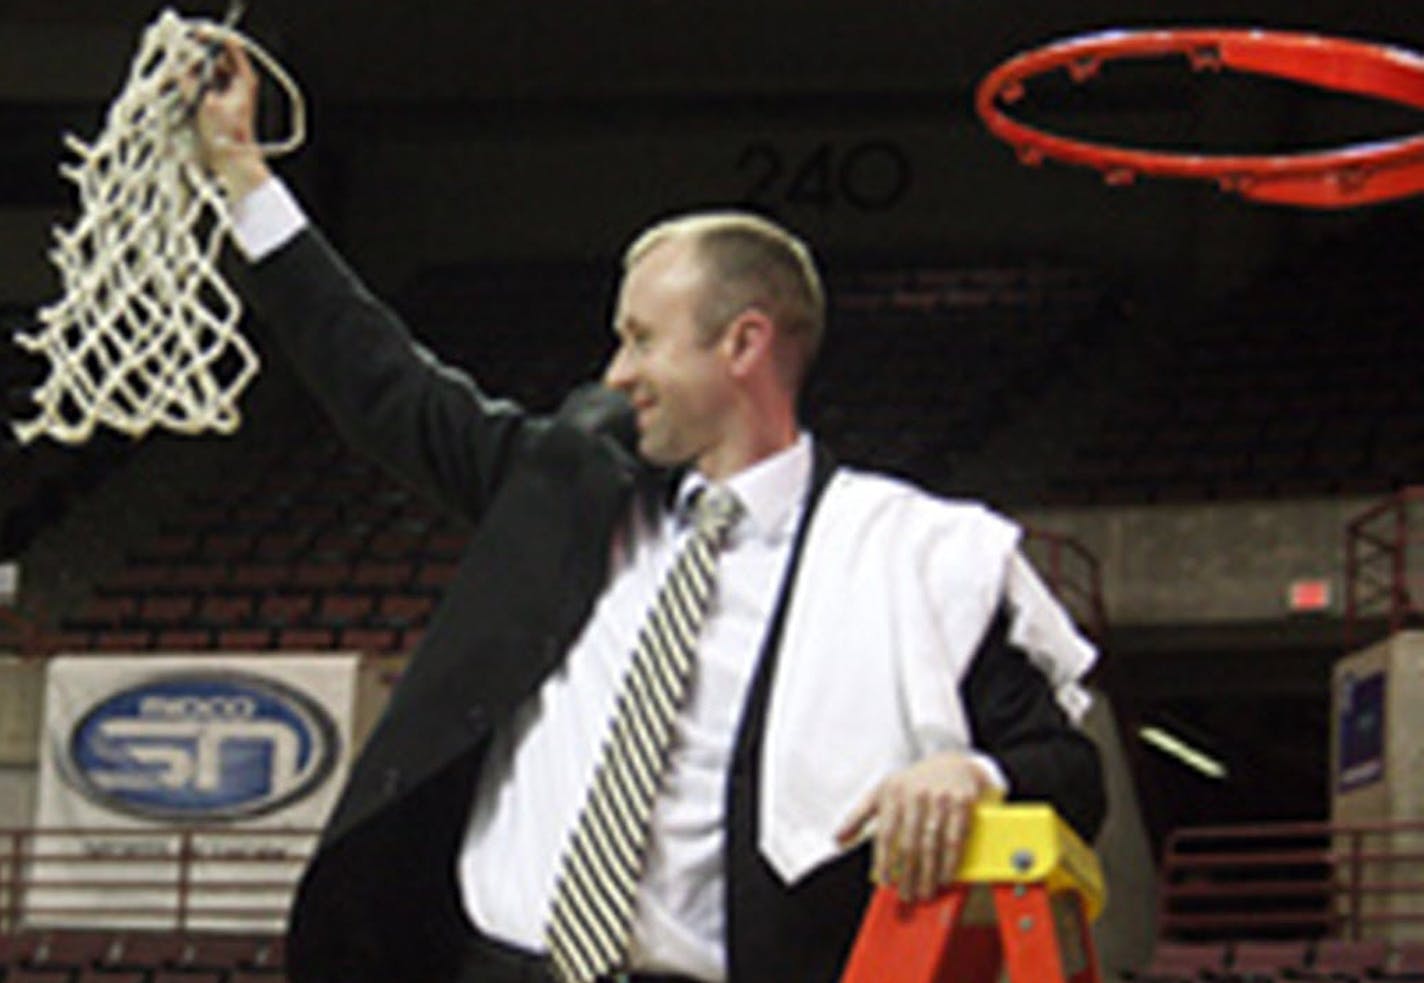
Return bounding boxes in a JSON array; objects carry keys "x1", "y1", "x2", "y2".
[{"x1": 604, "y1": 239, "x2": 732, "y2": 466}]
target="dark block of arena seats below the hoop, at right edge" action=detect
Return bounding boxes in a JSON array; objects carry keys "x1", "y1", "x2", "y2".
[{"x1": 1045, "y1": 215, "x2": 1424, "y2": 504}]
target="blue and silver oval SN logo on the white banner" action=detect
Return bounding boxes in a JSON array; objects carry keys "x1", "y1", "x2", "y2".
[{"x1": 67, "y1": 674, "x2": 337, "y2": 822}]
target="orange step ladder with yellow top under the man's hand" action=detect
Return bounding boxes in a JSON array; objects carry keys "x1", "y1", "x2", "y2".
[{"x1": 840, "y1": 803, "x2": 1106, "y2": 983}]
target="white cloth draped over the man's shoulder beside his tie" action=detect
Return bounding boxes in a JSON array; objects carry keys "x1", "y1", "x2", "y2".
[{"x1": 759, "y1": 469, "x2": 1095, "y2": 883}]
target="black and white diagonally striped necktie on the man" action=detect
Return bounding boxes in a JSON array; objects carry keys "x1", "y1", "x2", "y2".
[{"x1": 544, "y1": 484, "x2": 742, "y2": 983}]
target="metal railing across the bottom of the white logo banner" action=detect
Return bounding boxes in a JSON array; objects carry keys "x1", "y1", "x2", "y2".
[{"x1": 0, "y1": 828, "x2": 318, "y2": 933}]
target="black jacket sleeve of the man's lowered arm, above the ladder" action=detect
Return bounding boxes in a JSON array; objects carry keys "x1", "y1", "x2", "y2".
[{"x1": 960, "y1": 610, "x2": 1106, "y2": 843}]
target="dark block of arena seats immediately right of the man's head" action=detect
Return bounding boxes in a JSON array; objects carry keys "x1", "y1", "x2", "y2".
[{"x1": 807, "y1": 265, "x2": 1109, "y2": 487}]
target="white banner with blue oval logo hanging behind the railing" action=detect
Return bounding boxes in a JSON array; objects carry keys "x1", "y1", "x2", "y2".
[{"x1": 31, "y1": 652, "x2": 359, "y2": 932}]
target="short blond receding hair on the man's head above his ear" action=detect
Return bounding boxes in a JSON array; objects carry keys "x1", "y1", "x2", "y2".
[{"x1": 622, "y1": 211, "x2": 826, "y2": 392}]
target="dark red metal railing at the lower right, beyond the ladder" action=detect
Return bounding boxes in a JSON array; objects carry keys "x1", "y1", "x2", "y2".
[{"x1": 1158, "y1": 821, "x2": 1424, "y2": 940}]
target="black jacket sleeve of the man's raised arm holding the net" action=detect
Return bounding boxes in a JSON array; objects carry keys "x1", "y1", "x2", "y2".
[{"x1": 235, "y1": 228, "x2": 541, "y2": 519}]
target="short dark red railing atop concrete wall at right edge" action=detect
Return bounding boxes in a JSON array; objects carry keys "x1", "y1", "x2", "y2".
[{"x1": 1344, "y1": 486, "x2": 1424, "y2": 647}]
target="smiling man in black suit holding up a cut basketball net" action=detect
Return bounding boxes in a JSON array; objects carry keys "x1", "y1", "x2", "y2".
[{"x1": 198, "y1": 40, "x2": 1104, "y2": 983}]
